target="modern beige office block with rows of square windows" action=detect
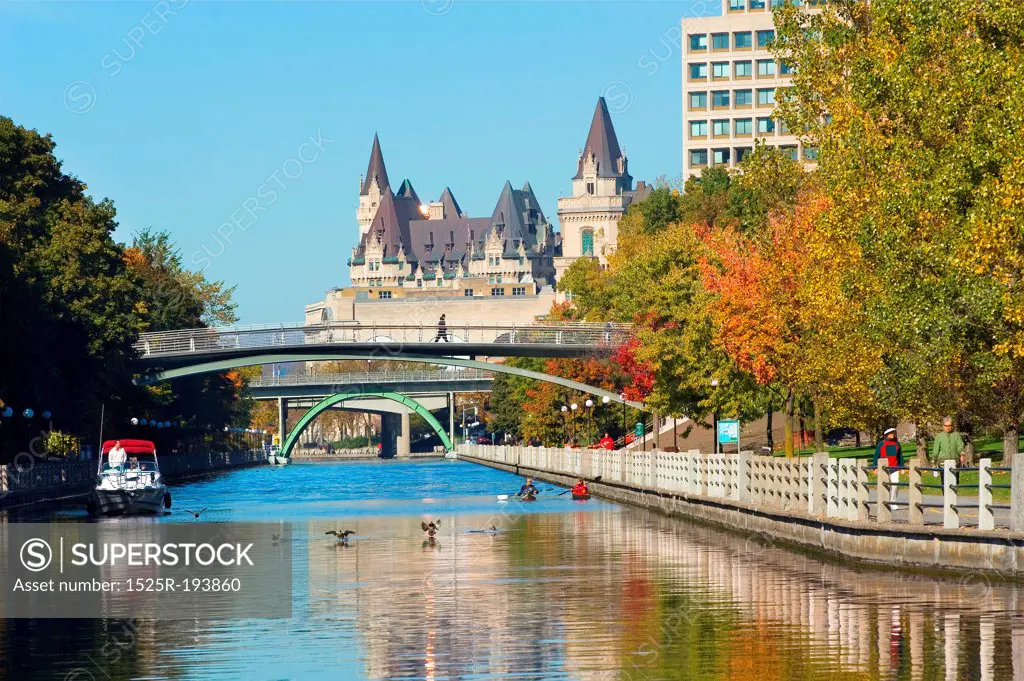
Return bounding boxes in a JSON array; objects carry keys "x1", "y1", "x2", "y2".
[{"x1": 682, "y1": 0, "x2": 820, "y2": 179}]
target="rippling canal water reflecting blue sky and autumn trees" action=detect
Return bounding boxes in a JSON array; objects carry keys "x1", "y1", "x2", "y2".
[{"x1": 0, "y1": 460, "x2": 1024, "y2": 681}]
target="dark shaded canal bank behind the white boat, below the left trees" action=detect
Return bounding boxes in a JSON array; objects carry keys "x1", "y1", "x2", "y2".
[{"x1": 0, "y1": 450, "x2": 266, "y2": 509}]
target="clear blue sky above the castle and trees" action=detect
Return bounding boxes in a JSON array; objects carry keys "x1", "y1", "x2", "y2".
[{"x1": 0, "y1": 0, "x2": 720, "y2": 324}]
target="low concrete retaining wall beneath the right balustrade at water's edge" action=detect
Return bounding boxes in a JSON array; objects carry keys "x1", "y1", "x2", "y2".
[{"x1": 459, "y1": 445, "x2": 1024, "y2": 579}]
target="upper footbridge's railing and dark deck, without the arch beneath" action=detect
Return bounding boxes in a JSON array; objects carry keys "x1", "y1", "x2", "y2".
[{"x1": 135, "y1": 322, "x2": 632, "y2": 367}]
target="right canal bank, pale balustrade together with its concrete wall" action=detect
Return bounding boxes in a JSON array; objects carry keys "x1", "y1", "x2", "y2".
[{"x1": 460, "y1": 444, "x2": 1024, "y2": 580}]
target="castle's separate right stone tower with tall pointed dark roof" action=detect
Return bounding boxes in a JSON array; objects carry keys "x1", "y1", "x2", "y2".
[{"x1": 555, "y1": 97, "x2": 651, "y2": 278}]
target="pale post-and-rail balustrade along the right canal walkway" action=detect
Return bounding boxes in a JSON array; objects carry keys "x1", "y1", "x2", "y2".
[{"x1": 460, "y1": 444, "x2": 1024, "y2": 531}]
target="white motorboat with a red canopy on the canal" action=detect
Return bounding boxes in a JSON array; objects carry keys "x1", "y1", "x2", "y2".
[{"x1": 88, "y1": 439, "x2": 171, "y2": 515}]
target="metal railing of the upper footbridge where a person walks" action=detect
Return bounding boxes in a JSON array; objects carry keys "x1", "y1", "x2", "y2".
[{"x1": 135, "y1": 322, "x2": 631, "y2": 357}]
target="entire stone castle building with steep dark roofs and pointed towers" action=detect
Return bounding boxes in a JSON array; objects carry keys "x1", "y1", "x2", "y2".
[{"x1": 305, "y1": 97, "x2": 650, "y2": 324}]
